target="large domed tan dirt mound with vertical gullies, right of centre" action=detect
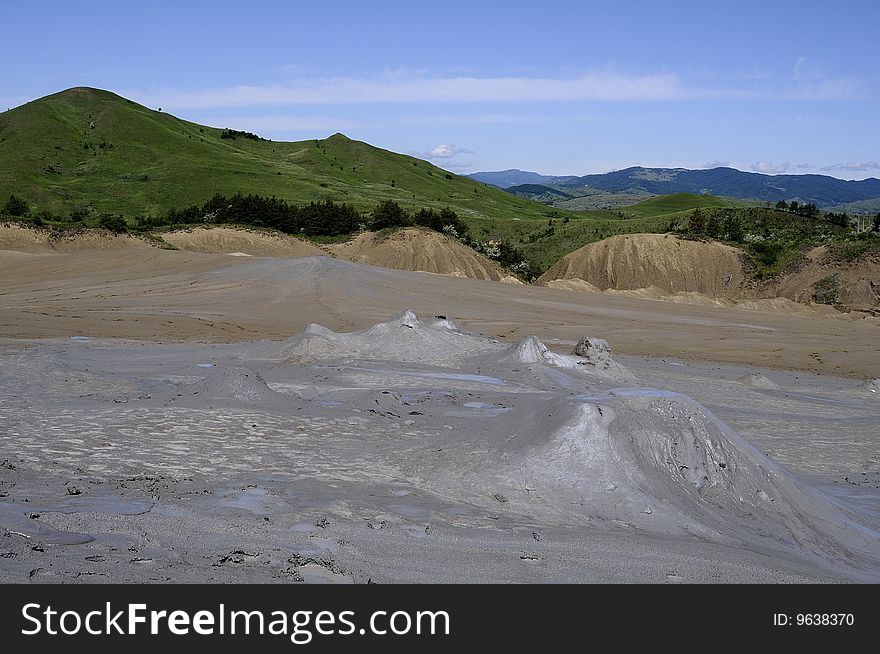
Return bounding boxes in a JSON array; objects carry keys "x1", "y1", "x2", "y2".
[{"x1": 538, "y1": 234, "x2": 744, "y2": 297}]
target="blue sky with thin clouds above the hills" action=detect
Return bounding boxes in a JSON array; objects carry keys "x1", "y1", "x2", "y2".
[{"x1": 0, "y1": 0, "x2": 880, "y2": 179}]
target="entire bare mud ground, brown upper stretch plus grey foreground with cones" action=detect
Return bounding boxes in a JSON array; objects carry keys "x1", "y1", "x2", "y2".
[{"x1": 0, "y1": 250, "x2": 880, "y2": 583}]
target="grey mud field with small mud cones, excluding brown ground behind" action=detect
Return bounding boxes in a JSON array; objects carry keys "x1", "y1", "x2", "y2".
[{"x1": 0, "y1": 312, "x2": 880, "y2": 583}]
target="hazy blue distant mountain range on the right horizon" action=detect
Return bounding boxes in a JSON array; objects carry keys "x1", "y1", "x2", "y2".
[{"x1": 469, "y1": 166, "x2": 880, "y2": 207}]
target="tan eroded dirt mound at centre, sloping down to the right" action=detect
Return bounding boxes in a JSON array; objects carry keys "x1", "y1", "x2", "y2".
[{"x1": 330, "y1": 228, "x2": 508, "y2": 282}]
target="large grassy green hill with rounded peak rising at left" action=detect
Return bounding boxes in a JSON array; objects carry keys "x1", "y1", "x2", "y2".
[{"x1": 0, "y1": 87, "x2": 572, "y2": 219}]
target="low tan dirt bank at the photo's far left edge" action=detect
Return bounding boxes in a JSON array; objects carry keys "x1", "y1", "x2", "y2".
[{"x1": 0, "y1": 223, "x2": 150, "y2": 253}]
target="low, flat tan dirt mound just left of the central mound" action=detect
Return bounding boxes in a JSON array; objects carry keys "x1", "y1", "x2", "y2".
[{"x1": 162, "y1": 227, "x2": 326, "y2": 257}]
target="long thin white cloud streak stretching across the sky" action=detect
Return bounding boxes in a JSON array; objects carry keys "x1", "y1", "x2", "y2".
[{"x1": 115, "y1": 63, "x2": 862, "y2": 119}]
